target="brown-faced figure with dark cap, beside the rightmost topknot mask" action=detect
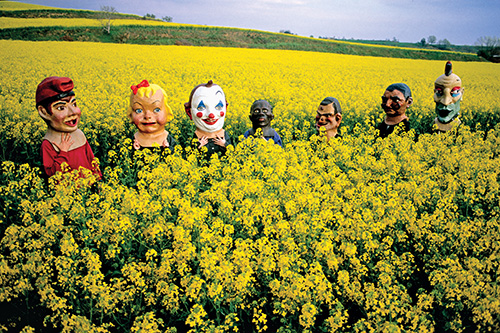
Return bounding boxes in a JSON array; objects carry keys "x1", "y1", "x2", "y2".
[{"x1": 377, "y1": 83, "x2": 413, "y2": 138}]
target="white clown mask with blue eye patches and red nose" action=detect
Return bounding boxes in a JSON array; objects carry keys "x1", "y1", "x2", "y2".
[{"x1": 188, "y1": 84, "x2": 226, "y2": 133}]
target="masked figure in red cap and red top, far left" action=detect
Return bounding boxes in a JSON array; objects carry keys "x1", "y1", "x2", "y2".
[{"x1": 36, "y1": 76, "x2": 102, "y2": 179}]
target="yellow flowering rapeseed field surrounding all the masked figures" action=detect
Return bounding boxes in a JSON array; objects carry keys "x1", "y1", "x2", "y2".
[{"x1": 0, "y1": 40, "x2": 500, "y2": 332}]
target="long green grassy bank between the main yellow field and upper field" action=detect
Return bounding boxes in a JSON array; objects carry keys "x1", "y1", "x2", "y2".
[{"x1": 0, "y1": 25, "x2": 480, "y2": 61}]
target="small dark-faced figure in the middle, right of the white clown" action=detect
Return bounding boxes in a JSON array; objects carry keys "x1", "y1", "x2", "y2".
[{"x1": 243, "y1": 99, "x2": 283, "y2": 147}]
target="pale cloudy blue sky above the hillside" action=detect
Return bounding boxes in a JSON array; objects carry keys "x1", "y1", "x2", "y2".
[{"x1": 14, "y1": 0, "x2": 500, "y2": 45}]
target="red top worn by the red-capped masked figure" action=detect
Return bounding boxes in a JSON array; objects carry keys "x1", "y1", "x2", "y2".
[{"x1": 41, "y1": 140, "x2": 102, "y2": 179}]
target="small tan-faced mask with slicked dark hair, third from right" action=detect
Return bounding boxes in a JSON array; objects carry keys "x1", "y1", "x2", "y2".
[{"x1": 316, "y1": 97, "x2": 342, "y2": 140}]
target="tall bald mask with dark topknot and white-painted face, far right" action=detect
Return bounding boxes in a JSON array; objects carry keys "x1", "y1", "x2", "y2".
[{"x1": 434, "y1": 61, "x2": 464, "y2": 132}]
